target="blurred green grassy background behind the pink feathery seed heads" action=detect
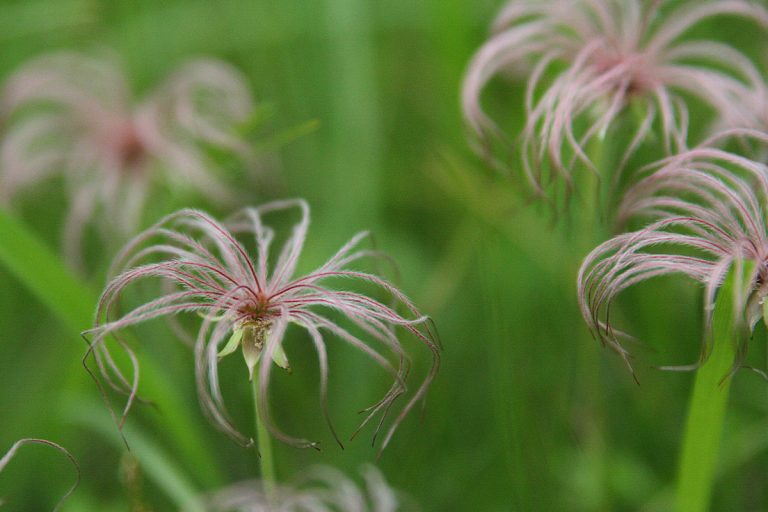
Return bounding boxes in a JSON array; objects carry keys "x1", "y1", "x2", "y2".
[{"x1": 0, "y1": 0, "x2": 768, "y2": 511}]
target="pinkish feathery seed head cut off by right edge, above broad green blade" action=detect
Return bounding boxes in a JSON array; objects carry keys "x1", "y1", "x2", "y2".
[{"x1": 578, "y1": 130, "x2": 768, "y2": 374}]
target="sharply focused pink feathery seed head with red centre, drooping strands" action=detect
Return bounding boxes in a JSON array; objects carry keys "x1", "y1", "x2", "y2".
[{"x1": 84, "y1": 199, "x2": 439, "y2": 449}]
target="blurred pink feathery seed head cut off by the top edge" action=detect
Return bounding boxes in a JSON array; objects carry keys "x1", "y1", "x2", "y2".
[{"x1": 462, "y1": 0, "x2": 768, "y2": 193}]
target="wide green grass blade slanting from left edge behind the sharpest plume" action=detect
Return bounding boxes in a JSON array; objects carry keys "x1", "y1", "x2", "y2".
[{"x1": 0, "y1": 209, "x2": 223, "y2": 483}]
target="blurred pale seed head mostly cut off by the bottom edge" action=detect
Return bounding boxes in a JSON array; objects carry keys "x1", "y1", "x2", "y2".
[{"x1": 207, "y1": 466, "x2": 408, "y2": 512}]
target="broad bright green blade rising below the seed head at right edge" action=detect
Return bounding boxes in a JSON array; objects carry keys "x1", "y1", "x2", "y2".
[{"x1": 676, "y1": 264, "x2": 750, "y2": 512}]
